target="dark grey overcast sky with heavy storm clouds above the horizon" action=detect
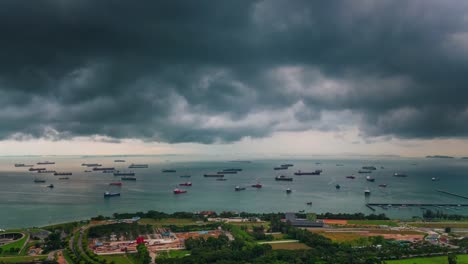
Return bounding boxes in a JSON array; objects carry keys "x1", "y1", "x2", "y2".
[{"x1": 0, "y1": 0, "x2": 468, "y2": 156}]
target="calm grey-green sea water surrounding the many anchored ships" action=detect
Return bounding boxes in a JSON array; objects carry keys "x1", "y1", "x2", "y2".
[{"x1": 0, "y1": 157, "x2": 468, "y2": 228}]
